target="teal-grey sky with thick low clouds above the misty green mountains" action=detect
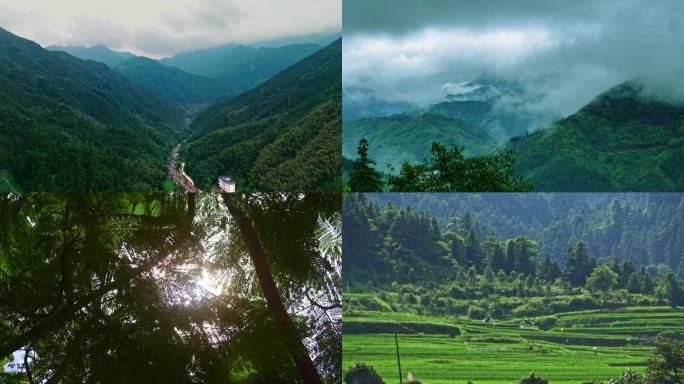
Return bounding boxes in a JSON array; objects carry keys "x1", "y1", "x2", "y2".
[{"x1": 343, "y1": 0, "x2": 684, "y2": 115}]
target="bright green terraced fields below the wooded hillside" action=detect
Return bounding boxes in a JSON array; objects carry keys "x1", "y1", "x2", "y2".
[{"x1": 343, "y1": 307, "x2": 684, "y2": 384}]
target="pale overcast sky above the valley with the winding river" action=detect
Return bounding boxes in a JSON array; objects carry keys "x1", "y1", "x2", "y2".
[{"x1": 0, "y1": 0, "x2": 342, "y2": 57}]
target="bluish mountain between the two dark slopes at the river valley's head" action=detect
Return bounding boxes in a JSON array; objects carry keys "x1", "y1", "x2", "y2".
[{"x1": 115, "y1": 57, "x2": 234, "y2": 112}]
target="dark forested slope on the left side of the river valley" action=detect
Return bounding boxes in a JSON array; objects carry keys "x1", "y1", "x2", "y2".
[{"x1": 0, "y1": 29, "x2": 182, "y2": 191}]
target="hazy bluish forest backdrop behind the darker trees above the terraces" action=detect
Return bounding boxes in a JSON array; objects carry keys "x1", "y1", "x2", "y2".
[{"x1": 345, "y1": 193, "x2": 684, "y2": 278}]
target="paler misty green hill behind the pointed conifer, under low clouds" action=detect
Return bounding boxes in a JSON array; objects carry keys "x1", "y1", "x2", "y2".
[{"x1": 342, "y1": 113, "x2": 497, "y2": 170}]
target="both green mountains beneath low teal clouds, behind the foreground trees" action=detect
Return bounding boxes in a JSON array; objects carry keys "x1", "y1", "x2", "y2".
[{"x1": 343, "y1": 80, "x2": 684, "y2": 192}]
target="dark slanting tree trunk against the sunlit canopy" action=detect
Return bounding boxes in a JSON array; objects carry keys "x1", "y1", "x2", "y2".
[{"x1": 223, "y1": 193, "x2": 322, "y2": 384}]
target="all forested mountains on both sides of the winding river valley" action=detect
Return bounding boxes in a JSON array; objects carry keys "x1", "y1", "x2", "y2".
[{"x1": 0, "y1": 30, "x2": 341, "y2": 191}]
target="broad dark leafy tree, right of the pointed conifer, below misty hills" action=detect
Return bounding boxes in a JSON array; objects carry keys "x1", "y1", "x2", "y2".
[{"x1": 388, "y1": 143, "x2": 532, "y2": 192}]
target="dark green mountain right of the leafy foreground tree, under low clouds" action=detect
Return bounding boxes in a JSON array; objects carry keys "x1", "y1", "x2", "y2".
[{"x1": 511, "y1": 82, "x2": 684, "y2": 191}]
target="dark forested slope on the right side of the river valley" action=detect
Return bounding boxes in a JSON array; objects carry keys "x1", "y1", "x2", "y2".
[{"x1": 182, "y1": 39, "x2": 342, "y2": 191}]
